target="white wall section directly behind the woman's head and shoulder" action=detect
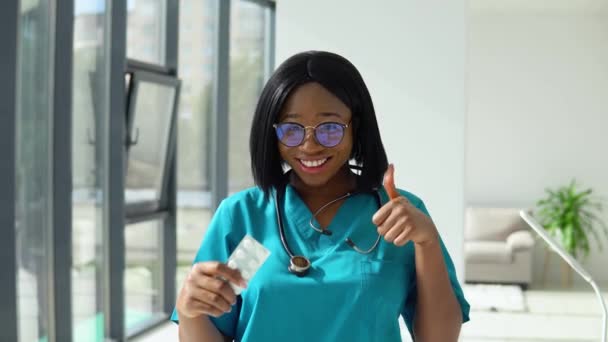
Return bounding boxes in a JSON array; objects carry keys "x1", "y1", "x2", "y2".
[{"x1": 276, "y1": 0, "x2": 465, "y2": 271}]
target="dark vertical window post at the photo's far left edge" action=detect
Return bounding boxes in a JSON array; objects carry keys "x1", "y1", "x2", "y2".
[{"x1": 0, "y1": 0, "x2": 19, "y2": 341}]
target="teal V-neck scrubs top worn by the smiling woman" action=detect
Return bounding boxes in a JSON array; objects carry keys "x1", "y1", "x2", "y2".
[{"x1": 171, "y1": 186, "x2": 469, "y2": 342}]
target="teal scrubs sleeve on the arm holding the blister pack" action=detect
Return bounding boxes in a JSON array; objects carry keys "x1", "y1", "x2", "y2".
[{"x1": 171, "y1": 200, "x2": 241, "y2": 337}]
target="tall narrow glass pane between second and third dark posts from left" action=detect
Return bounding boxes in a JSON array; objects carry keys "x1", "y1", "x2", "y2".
[{"x1": 72, "y1": 0, "x2": 109, "y2": 342}]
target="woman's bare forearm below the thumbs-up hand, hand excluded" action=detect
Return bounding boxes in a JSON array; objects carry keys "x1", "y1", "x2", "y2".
[{"x1": 414, "y1": 239, "x2": 462, "y2": 342}]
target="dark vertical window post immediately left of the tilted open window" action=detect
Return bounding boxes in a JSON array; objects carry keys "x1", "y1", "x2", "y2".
[{"x1": 103, "y1": 0, "x2": 127, "y2": 341}]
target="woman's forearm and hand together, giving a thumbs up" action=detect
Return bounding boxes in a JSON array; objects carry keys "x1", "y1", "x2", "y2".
[{"x1": 372, "y1": 164, "x2": 462, "y2": 342}]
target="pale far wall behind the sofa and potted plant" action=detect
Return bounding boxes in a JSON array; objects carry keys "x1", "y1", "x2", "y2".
[{"x1": 465, "y1": 1, "x2": 608, "y2": 282}]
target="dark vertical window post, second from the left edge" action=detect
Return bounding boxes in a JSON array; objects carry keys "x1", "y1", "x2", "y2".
[{"x1": 49, "y1": 0, "x2": 74, "y2": 341}]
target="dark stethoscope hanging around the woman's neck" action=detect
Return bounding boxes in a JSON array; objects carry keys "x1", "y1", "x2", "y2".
[{"x1": 273, "y1": 183, "x2": 382, "y2": 277}]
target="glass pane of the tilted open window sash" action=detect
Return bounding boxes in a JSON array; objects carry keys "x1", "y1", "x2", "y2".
[{"x1": 125, "y1": 82, "x2": 175, "y2": 203}]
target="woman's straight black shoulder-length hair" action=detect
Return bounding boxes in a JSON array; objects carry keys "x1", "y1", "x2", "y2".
[{"x1": 249, "y1": 51, "x2": 388, "y2": 194}]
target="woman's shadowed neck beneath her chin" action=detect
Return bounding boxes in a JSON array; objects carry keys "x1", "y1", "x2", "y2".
[{"x1": 289, "y1": 165, "x2": 357, "y2": 202}]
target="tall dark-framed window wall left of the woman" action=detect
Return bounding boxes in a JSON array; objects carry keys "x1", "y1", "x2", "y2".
[{"x1": 0, "y1": 0, "x2": 273, "y2": 342}]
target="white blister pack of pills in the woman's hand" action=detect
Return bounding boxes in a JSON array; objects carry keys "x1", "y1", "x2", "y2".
[{"x1": 227, "y1": 235, "x2": 270, "y2": 295}]
